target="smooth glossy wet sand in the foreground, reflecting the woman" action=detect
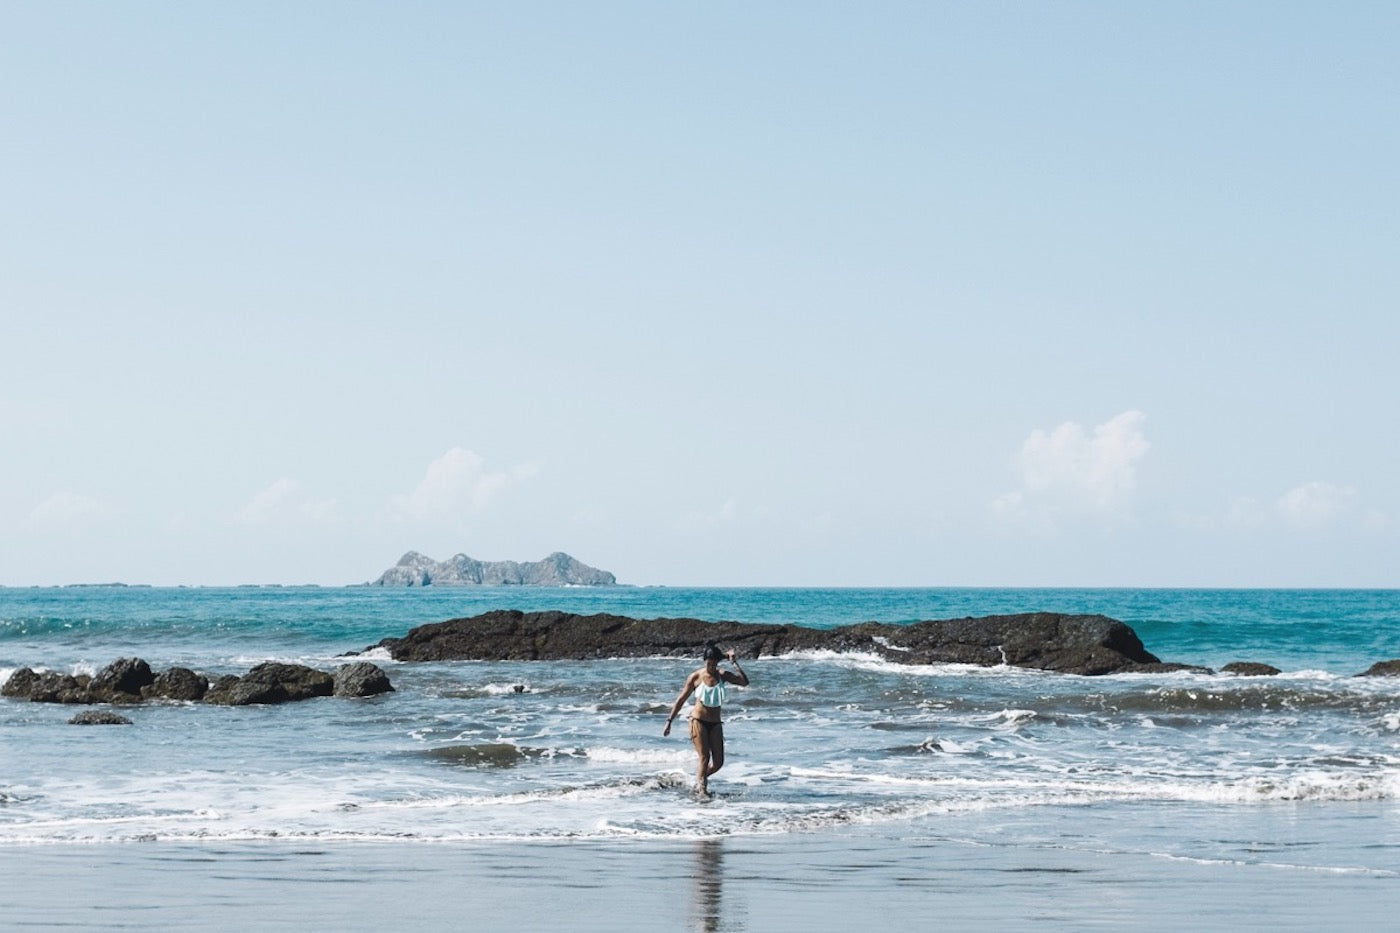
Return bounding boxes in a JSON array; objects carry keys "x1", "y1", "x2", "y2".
[{"x1": 0, "y1": 829, "x2": 1400, "y2": 933}]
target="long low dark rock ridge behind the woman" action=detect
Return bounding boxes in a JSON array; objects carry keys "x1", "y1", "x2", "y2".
[{"x1": 367, "y1": 609, "x2": 1161, "y2": 674}]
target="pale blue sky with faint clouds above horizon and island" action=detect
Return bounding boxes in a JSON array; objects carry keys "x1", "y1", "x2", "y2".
[{"x1": 0, "y1": 0, "x2": 1400, "y2": 587}]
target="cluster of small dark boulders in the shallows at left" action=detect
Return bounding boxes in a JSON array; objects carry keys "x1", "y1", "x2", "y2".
[{"x1": 0, "y1": 657, "x2": 393, "y2": 711}]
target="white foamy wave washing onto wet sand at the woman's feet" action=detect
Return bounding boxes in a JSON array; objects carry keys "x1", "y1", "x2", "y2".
[{"x1": 8, "y1": 762, "x2": 1400, "y2": 845}]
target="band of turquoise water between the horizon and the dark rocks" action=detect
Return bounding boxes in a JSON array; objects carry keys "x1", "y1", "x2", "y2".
[{"x1": 0, "y1": 587, "x2": 1400, "y2": 674}]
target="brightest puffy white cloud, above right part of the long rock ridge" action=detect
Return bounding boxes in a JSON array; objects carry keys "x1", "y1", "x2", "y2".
[{"x1": 991, "y1": 410, "x2": 1151, "y2": 525}]
